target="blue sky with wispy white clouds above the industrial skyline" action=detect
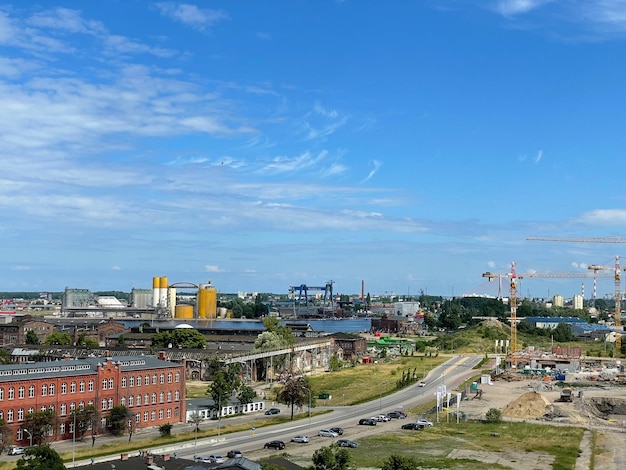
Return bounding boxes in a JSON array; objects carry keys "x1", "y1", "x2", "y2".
[{"x1": 0, "y1": 0, "x2": 626, "y2": 297}]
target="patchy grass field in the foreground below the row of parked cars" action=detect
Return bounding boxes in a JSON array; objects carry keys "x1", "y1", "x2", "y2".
[{"x1": 351, "y1": 422, "x2": 584, "y2": 470}]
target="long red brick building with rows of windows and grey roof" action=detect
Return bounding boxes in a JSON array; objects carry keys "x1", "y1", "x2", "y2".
[{"x1": 0, "y1": 353, "x2": 186, "y2": 445}]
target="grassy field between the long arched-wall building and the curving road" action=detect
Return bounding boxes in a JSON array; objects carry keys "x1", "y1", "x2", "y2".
[{"x1": 309, "y1": 355, "x2": 445, "y2": 406}]
